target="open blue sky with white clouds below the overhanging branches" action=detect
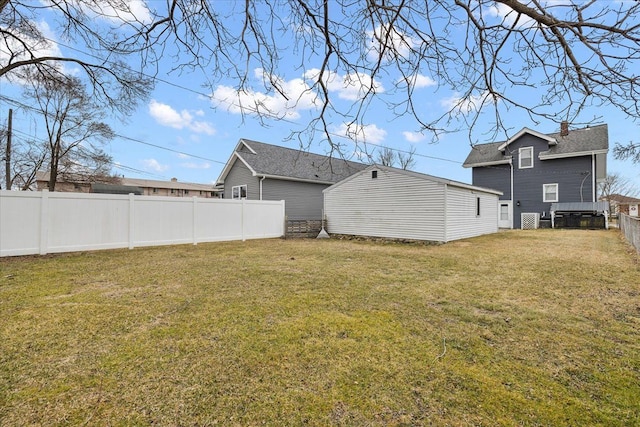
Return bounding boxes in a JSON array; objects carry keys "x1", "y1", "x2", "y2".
[{"x1": 0, "y1": 3, "x2": 640, "y2": 192}]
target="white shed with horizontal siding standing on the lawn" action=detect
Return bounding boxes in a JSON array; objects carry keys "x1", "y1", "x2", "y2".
[{"x1": 323, "y1": 165, "x2": 502, "y2": 242}]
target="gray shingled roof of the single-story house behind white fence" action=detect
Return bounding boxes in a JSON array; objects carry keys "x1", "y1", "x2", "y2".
[{"x1": 216, "y1": 139, "x2": 367, "y2": 184}]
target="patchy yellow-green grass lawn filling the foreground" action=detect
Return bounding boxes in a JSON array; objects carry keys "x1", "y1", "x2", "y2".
[{"x1": 0, "y1": 230, "x2": 640, "y2": 426}]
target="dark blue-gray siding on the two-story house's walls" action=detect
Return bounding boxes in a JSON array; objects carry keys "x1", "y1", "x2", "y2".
[{"x1": 472, "y1": 134, "x2": 593, "y2": 228}]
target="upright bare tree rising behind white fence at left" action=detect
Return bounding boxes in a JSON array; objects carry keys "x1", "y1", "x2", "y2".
[{"x1": 25, "y1": 74, "x2": 114, "y2": 191}]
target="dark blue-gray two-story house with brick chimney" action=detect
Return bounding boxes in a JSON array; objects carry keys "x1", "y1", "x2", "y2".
[{"x1": 463, "y1": 122, "x2": 609, "y2": 228}]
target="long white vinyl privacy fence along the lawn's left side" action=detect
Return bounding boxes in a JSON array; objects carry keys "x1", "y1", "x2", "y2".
[{"x1": 0, "y1": 190, "x2": 285, "y2": 257}]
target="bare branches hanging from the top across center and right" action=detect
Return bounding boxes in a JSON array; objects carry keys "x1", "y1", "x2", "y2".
[{"x1": 123, "y1": 0, "x2": 640, "y2": 149}]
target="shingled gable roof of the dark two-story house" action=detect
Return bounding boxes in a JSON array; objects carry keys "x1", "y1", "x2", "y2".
[{"x1": 462, "y1": 124, "x2": 609, "y2": 168}]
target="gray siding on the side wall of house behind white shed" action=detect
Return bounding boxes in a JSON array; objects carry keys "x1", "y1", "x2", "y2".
[{"x1": 262, "y1": 178, "x2": 328, "y2": 219}]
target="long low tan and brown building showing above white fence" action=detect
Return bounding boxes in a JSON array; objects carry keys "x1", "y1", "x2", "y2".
[{"x1": 36, "y1": 172, "x2": 221, "y2": 198}]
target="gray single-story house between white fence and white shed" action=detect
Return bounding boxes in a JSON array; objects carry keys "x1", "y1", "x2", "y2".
[{"x1": 217, "y1": 139, "x2": 367, "y2": 220}]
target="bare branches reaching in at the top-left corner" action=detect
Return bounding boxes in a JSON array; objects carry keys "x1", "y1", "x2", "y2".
[{"x1": 0, "y1": 0, "x2": 153, "y2": 117}]
